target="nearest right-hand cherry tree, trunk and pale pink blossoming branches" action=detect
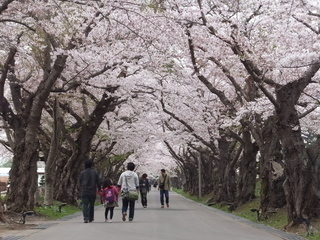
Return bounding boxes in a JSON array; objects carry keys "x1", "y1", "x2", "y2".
[{"x1": 165, "y1": 1, "x2": 319, "y2": 220}]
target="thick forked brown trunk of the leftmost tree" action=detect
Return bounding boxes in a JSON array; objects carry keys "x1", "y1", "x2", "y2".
[{"x1": 0, "y1": 52, "x2": 67, "y2": 212}]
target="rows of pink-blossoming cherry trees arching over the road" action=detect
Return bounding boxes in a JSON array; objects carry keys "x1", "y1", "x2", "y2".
[{"x1": 0, "y1": 0, "x2": 320, "y2": 228}]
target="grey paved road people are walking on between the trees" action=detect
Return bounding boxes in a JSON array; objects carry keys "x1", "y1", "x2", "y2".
[{"x1": 18, "y1": 191, "x2": 304, "y2": 240}]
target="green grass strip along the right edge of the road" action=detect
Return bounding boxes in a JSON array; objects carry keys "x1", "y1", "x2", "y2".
[{"x1": 173, "y1": 188, "x2": 320, "y2": 240}]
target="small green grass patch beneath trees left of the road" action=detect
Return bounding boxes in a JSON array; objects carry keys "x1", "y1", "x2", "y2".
[{"x1": 34, "y1": 202, "x2": 81, "y2": 220}]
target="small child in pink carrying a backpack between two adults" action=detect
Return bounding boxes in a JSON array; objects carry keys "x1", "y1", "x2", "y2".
[{"x1": 98, "y1": 178, "x2": 119, "y2": 223}]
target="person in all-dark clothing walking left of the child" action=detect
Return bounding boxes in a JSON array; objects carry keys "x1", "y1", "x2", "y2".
[{"x1": 79, "y1": 159, "x2": 101, "y2": 223}]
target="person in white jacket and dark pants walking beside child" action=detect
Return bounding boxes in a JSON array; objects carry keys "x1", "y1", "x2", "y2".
[{"x1": 118, "y1": 162, "x2": 139, "y2": 222}]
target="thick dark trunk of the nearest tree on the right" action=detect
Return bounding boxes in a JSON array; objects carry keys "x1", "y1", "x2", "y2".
[{"x1": 276, "y1": 81, "x2": 319, "y2": 222}]
